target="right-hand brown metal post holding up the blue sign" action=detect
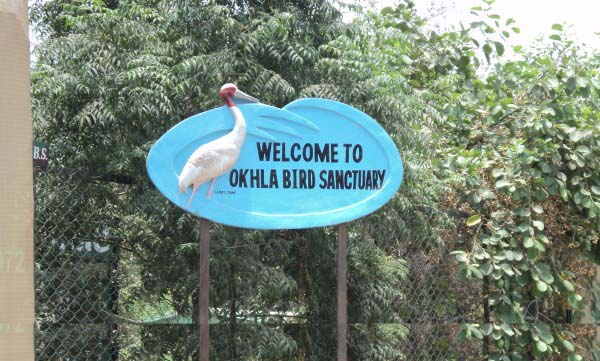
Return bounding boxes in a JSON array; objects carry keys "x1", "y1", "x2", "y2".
[{"x1": 337, "y1": 223, "x2": 348, "y2": 361}]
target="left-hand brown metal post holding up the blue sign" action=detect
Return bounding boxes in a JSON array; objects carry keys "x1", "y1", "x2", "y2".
[{"x1": 198, "y1": 218, "x2": 210, "y2": 361}]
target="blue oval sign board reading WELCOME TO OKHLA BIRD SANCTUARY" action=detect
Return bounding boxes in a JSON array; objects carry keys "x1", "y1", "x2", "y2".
[{"x1": 147, "y1": 98, "x2": 403, "y2": 229}]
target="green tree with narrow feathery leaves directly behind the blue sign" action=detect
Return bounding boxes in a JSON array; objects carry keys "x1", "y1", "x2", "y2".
[{"x1": 32, "y1": 1, "x2": 441, "y2": 360}]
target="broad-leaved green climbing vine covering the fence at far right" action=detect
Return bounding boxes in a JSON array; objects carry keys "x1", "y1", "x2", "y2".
[{"x1": 439, "y1": 10, "x2": 600, "y2": 360}]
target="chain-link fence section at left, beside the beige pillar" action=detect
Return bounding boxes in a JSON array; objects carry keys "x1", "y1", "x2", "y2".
[{"x1": 34, "y1": 169, "x2": 119, "y2": 360}]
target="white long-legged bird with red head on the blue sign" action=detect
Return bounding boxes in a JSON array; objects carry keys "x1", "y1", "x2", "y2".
[{"x1": 178, "y1": 83, "x2": 259, "y2": 208}]
